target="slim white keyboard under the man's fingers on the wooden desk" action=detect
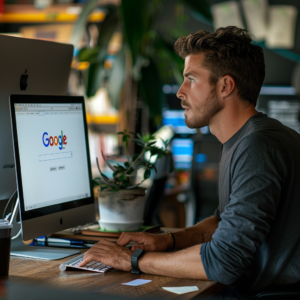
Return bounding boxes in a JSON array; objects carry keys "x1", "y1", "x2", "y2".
[{"x1": 59, "y1": 254, "x2": 112, "y2": 273}]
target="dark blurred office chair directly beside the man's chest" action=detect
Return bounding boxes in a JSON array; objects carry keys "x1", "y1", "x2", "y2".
[{"x1": 185, "y1": 135, "x2": 221, "y2": 226}]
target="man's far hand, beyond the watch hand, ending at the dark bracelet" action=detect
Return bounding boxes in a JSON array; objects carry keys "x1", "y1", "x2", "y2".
[{"x1": 117, "y1": 232, "x2": 173, "y2": 252}]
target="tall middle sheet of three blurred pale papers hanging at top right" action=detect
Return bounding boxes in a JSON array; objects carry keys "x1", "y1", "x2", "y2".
[{"x1": 242, "y1": 0, "x2": 268, "y2": 41}]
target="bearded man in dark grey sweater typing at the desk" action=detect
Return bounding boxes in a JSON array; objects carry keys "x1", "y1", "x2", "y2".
[{"x1": 82, "y1": 27, "x2": 300, "y2": 295}]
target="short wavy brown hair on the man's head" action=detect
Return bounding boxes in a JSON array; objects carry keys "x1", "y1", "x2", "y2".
[{"x1": 174, "y1": 26, "x2": 265, "y2": 105}]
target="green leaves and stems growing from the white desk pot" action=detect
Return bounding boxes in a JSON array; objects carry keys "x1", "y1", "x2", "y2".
[{"x1": 93, "y1": 130, "x2": 170, "y2": 192}]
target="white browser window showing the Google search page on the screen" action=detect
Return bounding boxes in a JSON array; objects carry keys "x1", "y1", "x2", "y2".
[{"x1": 15, "y1": 103, "x2": 91, "y2": 211}]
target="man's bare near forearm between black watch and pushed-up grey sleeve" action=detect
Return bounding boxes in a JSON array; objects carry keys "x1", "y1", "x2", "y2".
[{"x1": 139, "y1": 245, "x2": 208, "y2": 280}]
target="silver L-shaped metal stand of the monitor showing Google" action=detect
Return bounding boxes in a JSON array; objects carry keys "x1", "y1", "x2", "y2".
[{"x1": 10, "y1": 198, "x2": 80, "y2": 260}]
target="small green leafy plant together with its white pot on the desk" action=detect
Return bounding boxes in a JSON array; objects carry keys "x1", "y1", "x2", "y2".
[{"x1": 93, "y1": 130, "x2": 171, "y2": 231}]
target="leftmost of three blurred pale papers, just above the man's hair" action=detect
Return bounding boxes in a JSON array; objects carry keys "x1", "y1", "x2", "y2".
[{"x1": 211, "y1": 1, "x2": 244, "y2": 29}]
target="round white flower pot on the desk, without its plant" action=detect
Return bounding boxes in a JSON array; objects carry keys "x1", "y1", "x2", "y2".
[{"x1": 98, "y1": 188, "x2": 147, "y2": 231}]
